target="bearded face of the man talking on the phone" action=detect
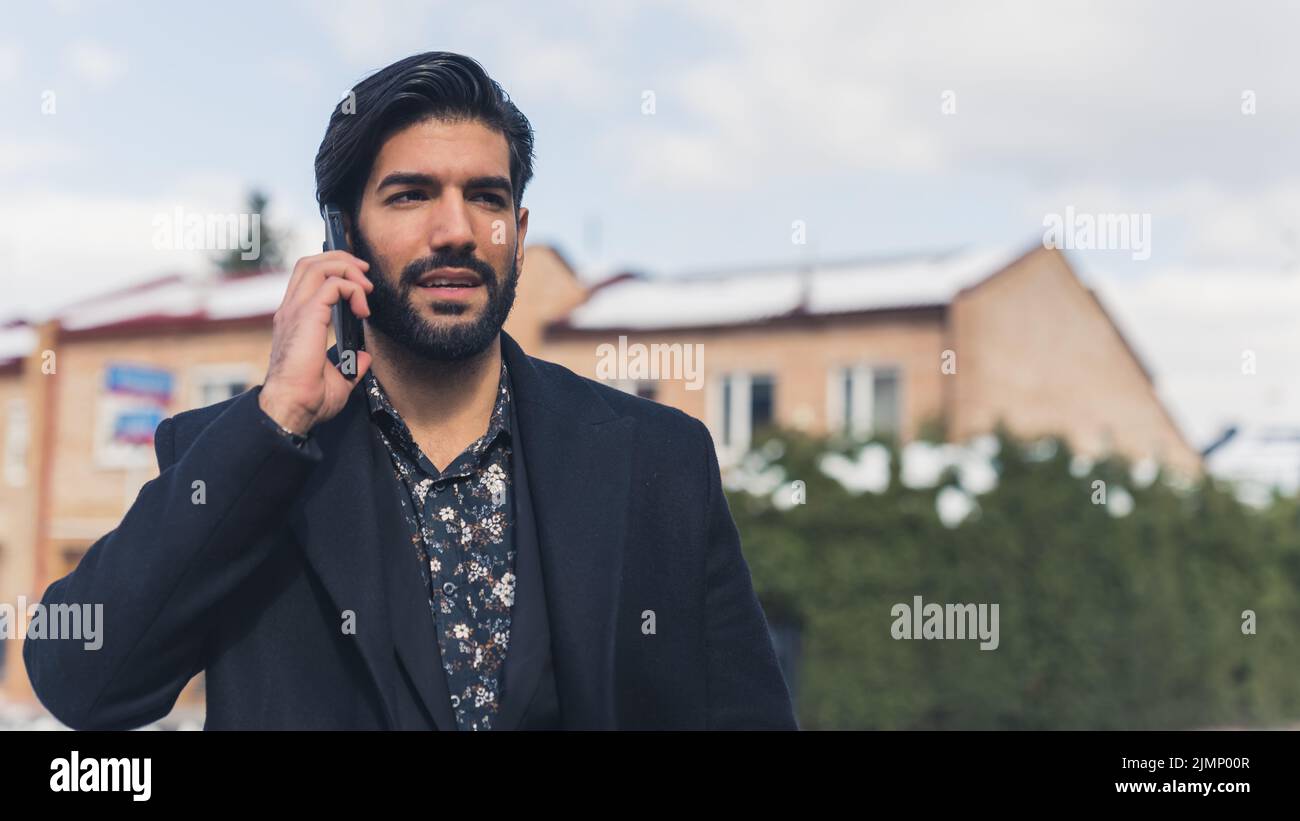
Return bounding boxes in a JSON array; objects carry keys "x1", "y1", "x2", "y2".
[{"x1": 351, "y1": 120, "x2": 528, "y2": 361}]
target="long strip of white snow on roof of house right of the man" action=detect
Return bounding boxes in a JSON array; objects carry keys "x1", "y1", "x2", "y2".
[{"x1": 568, "y1": 246, "x2": 1026, "y2": 330}]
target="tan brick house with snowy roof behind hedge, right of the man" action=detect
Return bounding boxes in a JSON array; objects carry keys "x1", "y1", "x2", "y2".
[{"x1": 542, "y1": 241, "x2": 1200, "y2": 474}]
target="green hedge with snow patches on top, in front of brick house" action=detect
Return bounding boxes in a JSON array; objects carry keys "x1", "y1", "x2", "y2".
[{"x1": 728, "y1": 431, "x2": 1300, "y2": 729}]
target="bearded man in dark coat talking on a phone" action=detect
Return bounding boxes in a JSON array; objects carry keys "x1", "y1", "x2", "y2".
[{"x1": 23, "y1": 52, "x2": 797, "y2": 730}]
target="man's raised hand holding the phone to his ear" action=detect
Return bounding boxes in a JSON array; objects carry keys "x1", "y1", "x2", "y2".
[{"x1": 257, "y1": 251, "x2": 374, "y2": 435}]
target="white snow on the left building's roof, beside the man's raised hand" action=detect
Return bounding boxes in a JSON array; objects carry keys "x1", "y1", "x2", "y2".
[{"x1": 59, "y1": 272, "x2": 290, "y2": 331}]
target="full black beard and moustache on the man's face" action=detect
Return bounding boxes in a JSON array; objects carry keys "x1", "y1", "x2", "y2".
[{"x1": 352, "y1": 230, "x2": 519, "y2": 362}]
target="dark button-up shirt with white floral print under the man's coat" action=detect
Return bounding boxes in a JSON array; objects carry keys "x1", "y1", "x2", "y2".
[{"x1": 364, "y1": 359, "x2": 515, "y2": 730}]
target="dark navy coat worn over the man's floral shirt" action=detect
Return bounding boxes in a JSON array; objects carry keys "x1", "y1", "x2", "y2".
[{"x1": 23, "y1": 333, "x2": 797, "y2": 730}]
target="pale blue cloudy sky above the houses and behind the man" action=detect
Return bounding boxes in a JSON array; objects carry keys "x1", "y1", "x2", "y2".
[{"x1": 0, "y1": 0, "x2": 1300, "y2": 446}]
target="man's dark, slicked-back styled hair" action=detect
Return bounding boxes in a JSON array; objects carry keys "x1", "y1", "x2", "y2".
[{"x1": 316, "y1": 52, "x2": 533, "y2": 225}]
